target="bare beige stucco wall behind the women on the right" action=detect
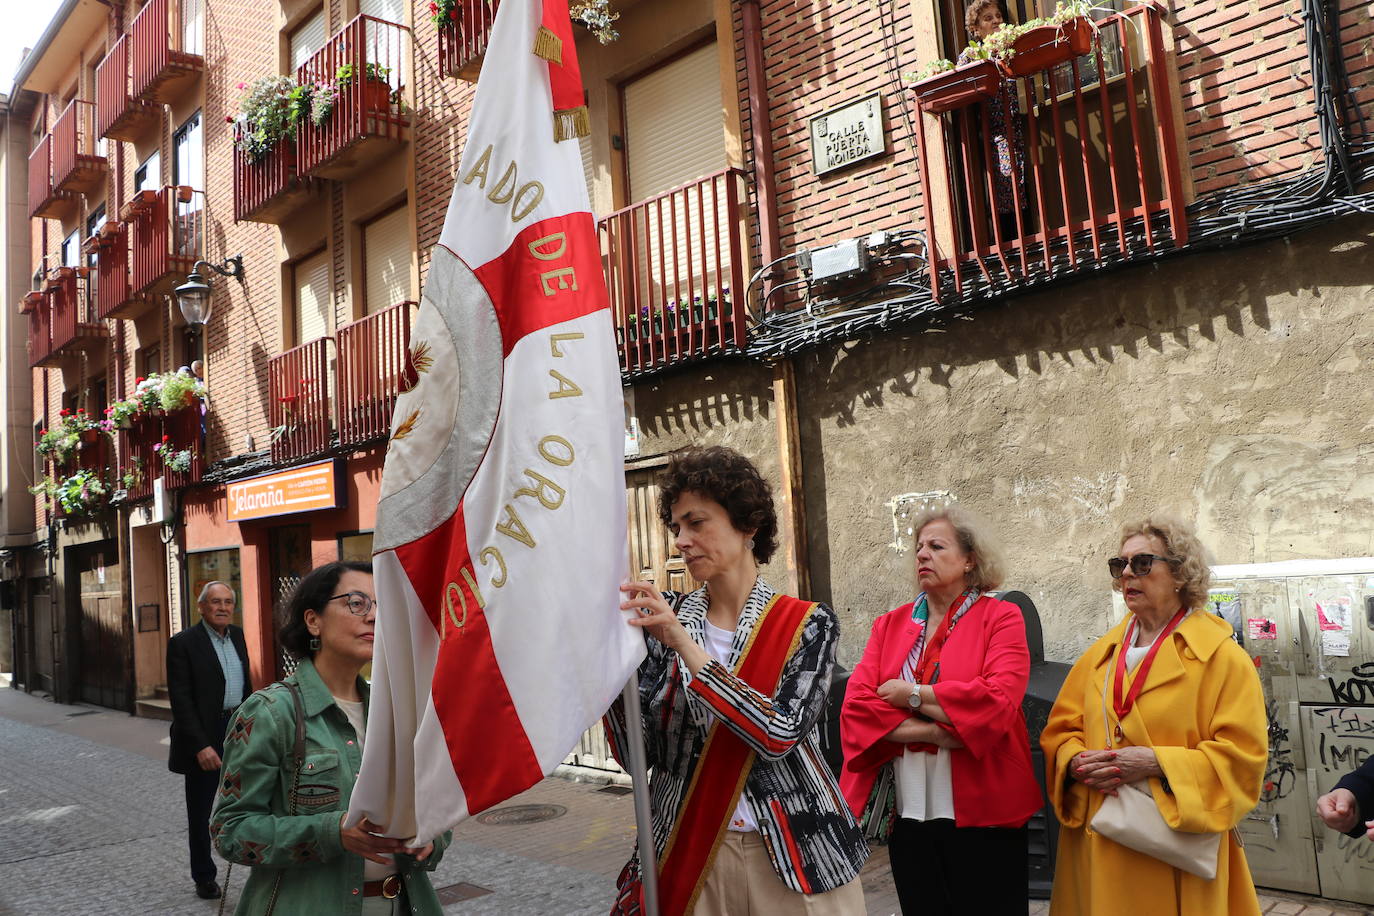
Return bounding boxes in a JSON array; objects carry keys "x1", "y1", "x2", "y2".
[{"x1": 797, "y1": 217, "x2": 1374, "y2": 665}]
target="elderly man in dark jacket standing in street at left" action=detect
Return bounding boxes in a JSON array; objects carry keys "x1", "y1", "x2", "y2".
[{"x1": 168, "y1": 582, "x2": 253, "y2": 900}]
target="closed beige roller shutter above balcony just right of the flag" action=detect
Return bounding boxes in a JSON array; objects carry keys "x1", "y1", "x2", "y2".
[{"x1": 625, "y1": 43, "x2": 728, "y2": 201}]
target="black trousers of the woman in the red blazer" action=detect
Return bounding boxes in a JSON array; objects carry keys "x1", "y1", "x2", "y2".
[{"x1": 888, "y1": 818, "x2": 1031, "y2": 916}]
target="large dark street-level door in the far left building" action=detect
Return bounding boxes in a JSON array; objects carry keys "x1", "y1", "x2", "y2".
[{"x1": 67, "y1": 541, "x2": 129, "y2": 709}]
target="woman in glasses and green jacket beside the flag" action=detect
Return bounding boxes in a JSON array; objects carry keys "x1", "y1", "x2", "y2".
[{"x1": 210, "y1": 563, "x2": 451, "y2": 916}]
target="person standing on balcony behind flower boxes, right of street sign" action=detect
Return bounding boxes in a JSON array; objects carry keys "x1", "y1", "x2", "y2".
[{"x1": 958, "y1": 0, "x2": 1031, "y2": 242}]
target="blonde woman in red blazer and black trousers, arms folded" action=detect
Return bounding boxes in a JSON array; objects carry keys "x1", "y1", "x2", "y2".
[{"x1": 840, "y1": 505, "x2": 1043, "y2": 916}]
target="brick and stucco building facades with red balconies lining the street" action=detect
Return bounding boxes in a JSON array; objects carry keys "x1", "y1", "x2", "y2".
[{"x1": 0, "y1": 0, "x2": 1374, "y2": 895}]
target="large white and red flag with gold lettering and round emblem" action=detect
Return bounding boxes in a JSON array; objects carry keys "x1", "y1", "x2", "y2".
[{"x1": 349, "y1": 0, "x2": 644, "y2": 845}]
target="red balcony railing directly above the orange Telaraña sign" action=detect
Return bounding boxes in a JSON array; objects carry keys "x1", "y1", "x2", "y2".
[{"x1": 267, "y1": 336, "x2": 333, "y2": 461}]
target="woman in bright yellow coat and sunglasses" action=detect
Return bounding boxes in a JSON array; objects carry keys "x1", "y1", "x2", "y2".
[{"x1": 1040, "y1": 518, "x2": 1268, "y2": 916}]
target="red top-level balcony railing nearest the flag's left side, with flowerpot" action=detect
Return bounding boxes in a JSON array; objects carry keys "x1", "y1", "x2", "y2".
[{"x1": 295, "y1": 16, "x2": 409, "y2": 179}]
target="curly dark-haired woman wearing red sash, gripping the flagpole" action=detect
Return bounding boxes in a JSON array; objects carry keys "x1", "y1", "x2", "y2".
[{"x1": 606, "y1": 446, "x2": 868, "y2": 916}]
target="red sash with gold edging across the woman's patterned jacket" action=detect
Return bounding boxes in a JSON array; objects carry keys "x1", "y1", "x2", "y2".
[{"x1": 658, "y1": 595, "x2": 816, "y2": 916}]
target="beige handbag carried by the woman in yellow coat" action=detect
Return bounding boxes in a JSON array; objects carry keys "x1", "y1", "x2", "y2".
[{"x1": 1091, "y1": 672, "x2": 1239, "y2": 880}]
